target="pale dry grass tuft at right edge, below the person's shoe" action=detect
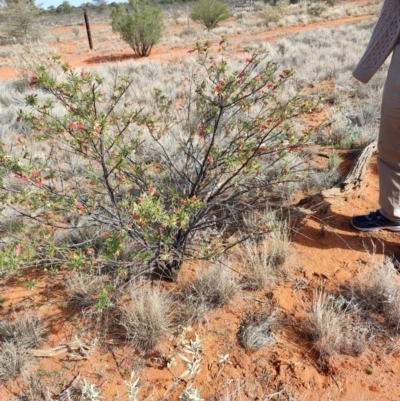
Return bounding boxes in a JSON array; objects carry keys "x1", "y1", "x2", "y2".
[{"x1": 350, "y1": 258, "x2": 400, "y2": 332}]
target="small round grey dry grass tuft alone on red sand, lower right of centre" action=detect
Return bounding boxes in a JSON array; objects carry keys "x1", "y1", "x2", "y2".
[{"x1": 238, "y1": 310, "x2": 277, "y2": 351}]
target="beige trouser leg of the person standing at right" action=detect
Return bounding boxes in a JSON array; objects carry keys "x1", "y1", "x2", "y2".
[{"x1": 378, "y1": 43, "x2": 400, "y2": 221}]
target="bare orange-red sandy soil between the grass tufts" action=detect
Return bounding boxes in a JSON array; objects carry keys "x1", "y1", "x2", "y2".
[{"x1": 0, "y1": 6, "x2": 400, "y2": 401}]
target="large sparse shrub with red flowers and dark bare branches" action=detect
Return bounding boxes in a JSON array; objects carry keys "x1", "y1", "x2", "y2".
[{"x1": 0, "y1": 42, "x2": 312, "y2": 278}]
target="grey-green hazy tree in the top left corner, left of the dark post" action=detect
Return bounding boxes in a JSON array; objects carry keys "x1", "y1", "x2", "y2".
[{"x1": 0, "y1": 0, "x2": 41, "y2": 42}]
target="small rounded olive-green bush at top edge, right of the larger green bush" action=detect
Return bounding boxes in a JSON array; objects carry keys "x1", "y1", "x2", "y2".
[{"x1": 190, "y1": 0, "x2": 231, "y2": 30}]
